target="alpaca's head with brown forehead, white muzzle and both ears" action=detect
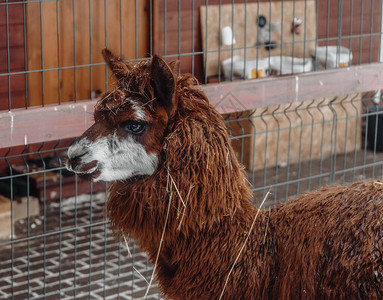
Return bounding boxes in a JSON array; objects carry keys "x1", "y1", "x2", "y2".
[{"x1": 67, "y1": 49, "x2": 177, "y2": 181}]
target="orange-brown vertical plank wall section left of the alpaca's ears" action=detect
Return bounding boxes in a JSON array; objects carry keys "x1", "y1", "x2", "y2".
[{"x1": 26, "y1": 0, "x2": 149, "y2": 106}]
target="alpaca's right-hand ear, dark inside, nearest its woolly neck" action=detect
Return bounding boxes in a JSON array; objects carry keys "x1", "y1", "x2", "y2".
[{"x1": 150, "y1": 55, "x2": 177, "y2": 116}]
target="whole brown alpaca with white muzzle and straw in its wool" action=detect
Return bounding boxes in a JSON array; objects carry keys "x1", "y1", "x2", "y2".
[{"x1": 68, "y1": 50, "x2": 383, "y2": 299}]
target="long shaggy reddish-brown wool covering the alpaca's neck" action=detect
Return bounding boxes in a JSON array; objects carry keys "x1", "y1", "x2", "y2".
[{"x1": 107, "y1": 90, "x2": 254, "y2": 248}]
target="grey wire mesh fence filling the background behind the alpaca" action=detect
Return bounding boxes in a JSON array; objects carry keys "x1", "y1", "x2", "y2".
[{"x1": 0, "y1": 0, "x2": 383, "y2": 299}]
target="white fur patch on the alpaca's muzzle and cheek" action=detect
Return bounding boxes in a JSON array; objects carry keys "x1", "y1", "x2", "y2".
[{"x1": 68, "y1": 134, "x2": 158, "y2": 181}]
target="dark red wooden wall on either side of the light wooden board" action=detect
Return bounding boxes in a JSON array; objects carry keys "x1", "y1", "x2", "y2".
[{"x1": 153, "y1": 0, "x2": 381, "y2": 82}]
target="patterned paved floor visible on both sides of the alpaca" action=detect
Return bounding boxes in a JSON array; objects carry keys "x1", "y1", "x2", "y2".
[{"x1": 0, "y1": 151, "x2": 383, "y2": 299}]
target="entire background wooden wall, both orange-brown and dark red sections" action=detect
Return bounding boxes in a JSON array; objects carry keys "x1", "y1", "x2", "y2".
[{"x1": 0, "y1": 0, "x2": 381, "y2": 110}]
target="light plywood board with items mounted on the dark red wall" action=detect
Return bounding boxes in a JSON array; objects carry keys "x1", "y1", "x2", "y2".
[{"x1": 200, "y1": 0, "x2": 316, "y2": 77}]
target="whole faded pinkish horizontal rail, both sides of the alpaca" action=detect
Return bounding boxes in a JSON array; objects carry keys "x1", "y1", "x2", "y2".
[{"x1": 0, "y1": 63, "x2": 383, "y2": 148}]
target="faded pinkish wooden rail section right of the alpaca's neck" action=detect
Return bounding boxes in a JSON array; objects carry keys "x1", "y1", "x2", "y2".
[{"x1": 205, "y1": 63, "x2": 383, "y2": 113}]
